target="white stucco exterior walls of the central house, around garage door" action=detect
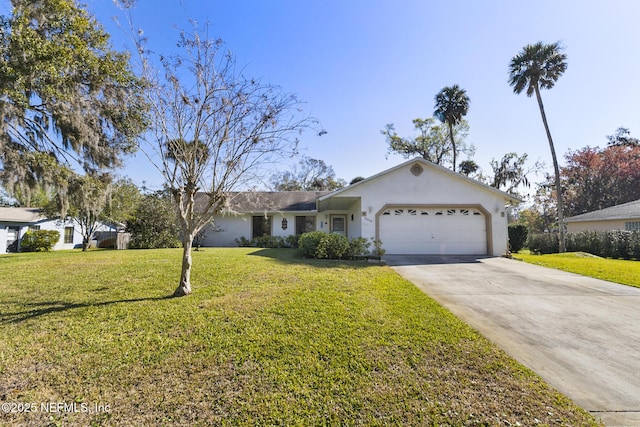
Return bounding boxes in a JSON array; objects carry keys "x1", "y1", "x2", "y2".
[{"x1": 202, "y1": 160, "x2": 513, "y2": 256}]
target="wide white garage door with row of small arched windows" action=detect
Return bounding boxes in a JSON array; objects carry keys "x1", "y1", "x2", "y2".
[{"x1": 379, "y1": 207, "x2": 487, "y2": 255}]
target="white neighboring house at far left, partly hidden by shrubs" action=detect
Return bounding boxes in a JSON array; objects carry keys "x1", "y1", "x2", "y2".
[{"x1": 0, "y1": 207, "x2": 117, "y2": 254}]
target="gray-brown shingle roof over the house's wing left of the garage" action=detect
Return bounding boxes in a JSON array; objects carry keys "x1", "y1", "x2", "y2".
[{"x1": 221, "y1": 191, "x2": 330, "y2": 213}]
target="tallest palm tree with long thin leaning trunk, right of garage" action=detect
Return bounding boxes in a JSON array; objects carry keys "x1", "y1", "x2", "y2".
[{"x1": 509, "y1": 42, "x2": 567, "y2": 252}]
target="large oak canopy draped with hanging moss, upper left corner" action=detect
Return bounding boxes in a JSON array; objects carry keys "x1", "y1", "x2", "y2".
[{"x1": 0, "y1": 0, "x2": 147, "y2": 199}]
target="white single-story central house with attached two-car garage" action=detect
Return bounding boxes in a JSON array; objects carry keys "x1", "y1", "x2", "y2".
[{"x1": 200, "y1": 159, "x2": 520, "y2": 256}]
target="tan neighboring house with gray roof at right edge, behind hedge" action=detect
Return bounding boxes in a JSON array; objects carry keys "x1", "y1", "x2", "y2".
[{"x1": 565, "y1": 200, "x2": 640, "y2": 232}]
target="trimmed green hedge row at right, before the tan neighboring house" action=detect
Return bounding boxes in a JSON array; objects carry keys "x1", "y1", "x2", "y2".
[{"x1": 527, "y1": 230, "x2": 640, "y2": 260}]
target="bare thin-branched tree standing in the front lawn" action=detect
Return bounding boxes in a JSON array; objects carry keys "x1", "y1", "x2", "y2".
[{"x1": 138, "y1": 31, "x2": 312, "y2": 296}]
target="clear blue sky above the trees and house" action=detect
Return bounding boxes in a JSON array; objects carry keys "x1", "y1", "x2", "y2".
[{"x1": 6, "y1": 0, "x2": 640, "y2": 193}]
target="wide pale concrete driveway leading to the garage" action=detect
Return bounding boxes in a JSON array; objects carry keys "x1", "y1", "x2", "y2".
[{"x1": 385, "y1": 255, "x2": 640, "y2": 426}]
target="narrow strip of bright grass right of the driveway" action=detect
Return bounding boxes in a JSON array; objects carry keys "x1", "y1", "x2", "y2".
[{"x1": 513, "y1": 252, "x2": 640, "y2": 288}]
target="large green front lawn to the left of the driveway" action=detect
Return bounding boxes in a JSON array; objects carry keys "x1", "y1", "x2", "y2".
[{"x1": 0, "y1": 248, "x2": 595, "y2": 426}]
